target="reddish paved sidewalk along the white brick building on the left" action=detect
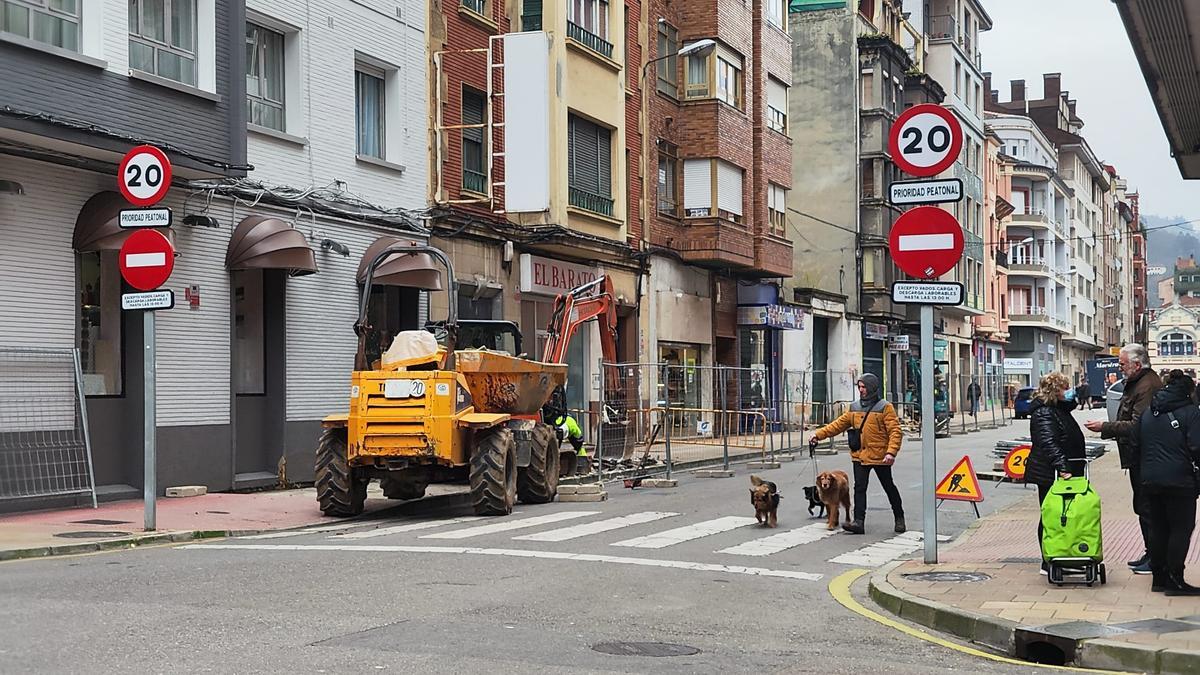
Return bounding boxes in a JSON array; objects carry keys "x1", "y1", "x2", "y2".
[{"x1": 0, "y1": 483, "x2": 467, "y2": 561}]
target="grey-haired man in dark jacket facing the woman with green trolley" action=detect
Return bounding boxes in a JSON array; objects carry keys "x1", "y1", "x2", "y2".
[{"x1": 1086, "y1": 342, "x2": 1163, "y2": 574}]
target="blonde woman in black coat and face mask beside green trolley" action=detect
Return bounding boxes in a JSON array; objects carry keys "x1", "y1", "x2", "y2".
[{"x1": 1025, "y1": 372, "x2": 1087, "y2": 574}]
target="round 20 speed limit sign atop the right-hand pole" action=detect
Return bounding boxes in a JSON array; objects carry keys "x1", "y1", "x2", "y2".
[{"x1": 888, "y1": 103, "x2": 962, "y2": 177}]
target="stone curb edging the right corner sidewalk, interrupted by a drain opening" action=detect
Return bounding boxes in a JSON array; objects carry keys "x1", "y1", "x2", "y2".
[{"x1": 868, "y1": 561, "x2": 1200, "y2": 675}]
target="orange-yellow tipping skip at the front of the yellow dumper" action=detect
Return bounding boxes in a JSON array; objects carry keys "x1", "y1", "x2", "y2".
[{"x1": 455, "y1": 350, "x2": 566, "y2": 416}]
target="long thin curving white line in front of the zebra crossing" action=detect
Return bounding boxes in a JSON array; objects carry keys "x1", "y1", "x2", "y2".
[{"x1": 176, "y1": 538, "x2": 822, "y2": 581}]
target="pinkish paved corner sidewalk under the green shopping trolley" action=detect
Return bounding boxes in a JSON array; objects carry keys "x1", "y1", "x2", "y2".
[{"x1": 870, "y1": 450, "x2": 1200, "y2": 674}]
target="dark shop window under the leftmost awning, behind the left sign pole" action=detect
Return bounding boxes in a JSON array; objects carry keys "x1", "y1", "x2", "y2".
[{"x1": 78, "y1": 251, "x2": 122, "y2": 396}]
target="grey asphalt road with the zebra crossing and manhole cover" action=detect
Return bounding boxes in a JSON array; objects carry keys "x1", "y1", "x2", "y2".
[{"x1": 0, "y1": 413, "x2": 1099, "y2": 675}]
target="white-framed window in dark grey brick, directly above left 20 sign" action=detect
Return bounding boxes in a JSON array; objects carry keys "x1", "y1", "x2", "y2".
[{"x1": 128, "y1": 0, "x2": 197, "y2": 86}]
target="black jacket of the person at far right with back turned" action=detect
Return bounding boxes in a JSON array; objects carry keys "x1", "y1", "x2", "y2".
[{"x1": 1140, "y1": 384, "x2": 1200, "y2": 490}]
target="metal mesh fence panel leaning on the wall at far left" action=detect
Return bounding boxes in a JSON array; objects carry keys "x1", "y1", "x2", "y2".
[{"x1": 0, "y1": 347, "x2": 96, "y2": 507}]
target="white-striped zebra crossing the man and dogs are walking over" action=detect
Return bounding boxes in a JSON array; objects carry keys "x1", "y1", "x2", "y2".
[{"x1": 231, "y1": 509, "x2": 949, "y2": 568}]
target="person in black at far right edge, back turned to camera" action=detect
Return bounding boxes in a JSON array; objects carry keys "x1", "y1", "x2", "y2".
[{"x1": 1139, "y1": 370, "x2": 1200, "y2": 596}]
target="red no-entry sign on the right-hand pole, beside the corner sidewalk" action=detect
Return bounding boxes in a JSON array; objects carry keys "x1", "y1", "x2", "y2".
[{"x1": 888, "y1": 207, "x2": 962, "y2": 279}]
